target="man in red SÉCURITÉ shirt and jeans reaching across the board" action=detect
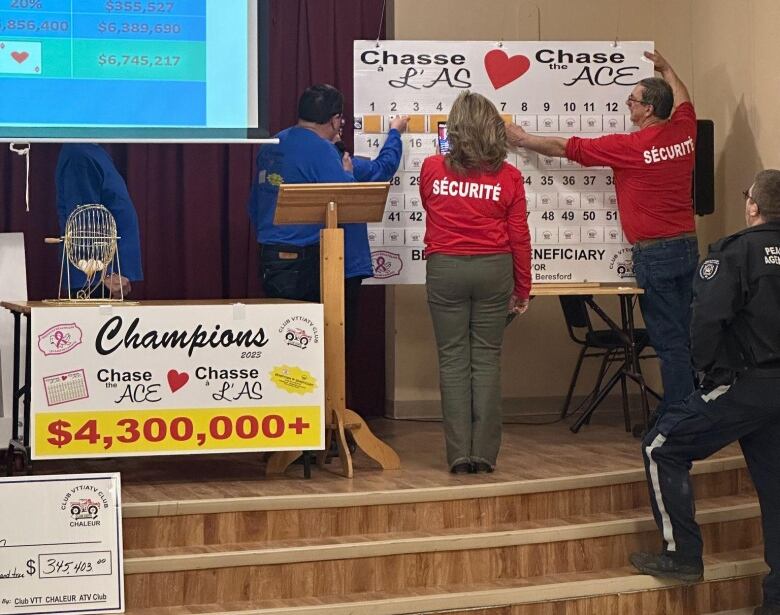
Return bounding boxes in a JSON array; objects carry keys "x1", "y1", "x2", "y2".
[{"x1": 507, "y1": 52, "x2": 699, "y2": 413}]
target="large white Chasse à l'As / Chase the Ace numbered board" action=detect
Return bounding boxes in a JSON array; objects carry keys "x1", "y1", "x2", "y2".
[{"x1": 354, "y1": 41, "x2": 653, "y2": 284}]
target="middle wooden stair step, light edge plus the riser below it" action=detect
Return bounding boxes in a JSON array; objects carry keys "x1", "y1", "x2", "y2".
[{"x1": 125, "y1": 498, "x2": 761, "y2": 608}]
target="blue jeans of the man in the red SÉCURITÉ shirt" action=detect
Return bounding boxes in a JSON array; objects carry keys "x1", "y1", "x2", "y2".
[{"x1": 634, "y1": 237, "x2": 699, "y2": 413}]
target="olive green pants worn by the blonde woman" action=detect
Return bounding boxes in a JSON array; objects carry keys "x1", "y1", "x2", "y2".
[{"x1": 426, "y1": 254, "x2": 514, "y2": 468}]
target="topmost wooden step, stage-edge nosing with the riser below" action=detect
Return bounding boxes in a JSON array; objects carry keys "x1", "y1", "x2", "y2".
[{"x1": 123, "y1": 458, "x2": 754, "y2": 551}]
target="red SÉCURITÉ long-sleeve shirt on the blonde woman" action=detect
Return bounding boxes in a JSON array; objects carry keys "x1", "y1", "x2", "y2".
[{"x1": 420, "y1": 156, "x2": 531, "y2": 300}]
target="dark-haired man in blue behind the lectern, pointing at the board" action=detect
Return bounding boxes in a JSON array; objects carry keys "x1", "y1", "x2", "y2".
[{"x1": 248, "y1": 84, "x2": 408, "y2": 340}]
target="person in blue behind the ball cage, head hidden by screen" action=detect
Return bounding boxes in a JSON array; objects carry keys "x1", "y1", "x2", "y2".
[{"x1": 55, "y1": 143, "x2": 143, "y2": 297}]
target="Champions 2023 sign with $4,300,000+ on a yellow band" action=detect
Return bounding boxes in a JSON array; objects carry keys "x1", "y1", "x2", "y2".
[{"x1": 31, "y1": 302, "x2": 324, "y2": 459}]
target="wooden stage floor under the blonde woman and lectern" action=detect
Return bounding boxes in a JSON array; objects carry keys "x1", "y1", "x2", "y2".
[{"x1": 27, "y1": 417, "x2": 744, "y2": 506}]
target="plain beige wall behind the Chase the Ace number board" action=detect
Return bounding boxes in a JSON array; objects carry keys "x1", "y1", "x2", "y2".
[{"x1": 387, "y1": 0, "x2": 768, "y2": 415}]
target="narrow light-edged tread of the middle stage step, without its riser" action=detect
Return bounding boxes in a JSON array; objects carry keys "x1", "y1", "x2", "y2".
[{"x1": 124, "y1": 495, "x2": 760, "y2": 574}]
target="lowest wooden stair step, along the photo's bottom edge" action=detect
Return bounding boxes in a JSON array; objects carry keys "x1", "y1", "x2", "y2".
[{"x1": 126, "y1": 547, "x2": 766, "y2": 615}]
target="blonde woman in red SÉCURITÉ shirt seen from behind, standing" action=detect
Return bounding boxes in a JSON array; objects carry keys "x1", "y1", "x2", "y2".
[{"x1": 420, "y1": 92, "x2": 531, "y2": 474}]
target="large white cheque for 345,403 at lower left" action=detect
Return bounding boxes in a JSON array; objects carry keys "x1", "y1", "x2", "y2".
[{"x1": 0, "y1": 473, "x2": 124, "y2": 615}]
